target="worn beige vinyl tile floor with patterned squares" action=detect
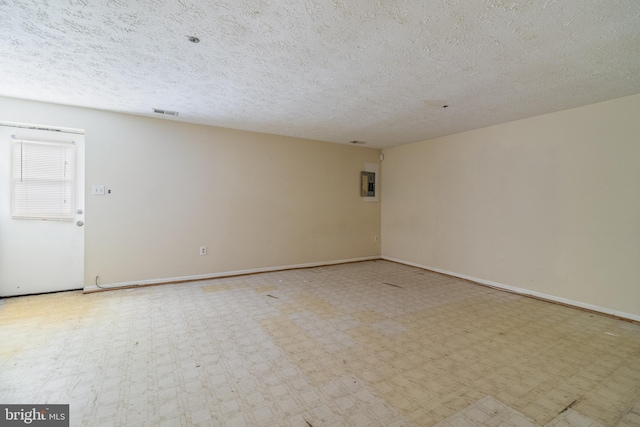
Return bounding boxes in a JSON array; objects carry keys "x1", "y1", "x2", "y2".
[{"x1": 0, "y1": 260, "x2": 640, "y2": 427}]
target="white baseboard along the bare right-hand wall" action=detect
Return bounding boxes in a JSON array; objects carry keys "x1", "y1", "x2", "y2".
[{"x1": 381, "y1": 256, "x2": 640, "y2": 322}]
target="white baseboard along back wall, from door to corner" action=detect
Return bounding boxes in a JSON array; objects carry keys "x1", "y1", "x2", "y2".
[{"x1": 83, "y1": 255, "x2": 380, "y2": 294}]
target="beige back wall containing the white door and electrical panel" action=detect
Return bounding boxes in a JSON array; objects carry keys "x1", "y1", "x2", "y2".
[{"x1": 0, "y1": 98, "x2": 380, "y2": 284}]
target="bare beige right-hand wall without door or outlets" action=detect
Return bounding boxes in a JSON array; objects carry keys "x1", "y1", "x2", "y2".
[{"x1": 382, "y1": 95, "x2": 640, "y2": 316}]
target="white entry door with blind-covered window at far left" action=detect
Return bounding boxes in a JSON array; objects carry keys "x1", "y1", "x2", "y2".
[{"x1": 0, "y1": 124, "x2": 84, "y2": 296}]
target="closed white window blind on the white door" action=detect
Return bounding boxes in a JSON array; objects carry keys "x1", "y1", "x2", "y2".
[{"x1": 11, "y1": 139, "x2": 76, "y2": 221}]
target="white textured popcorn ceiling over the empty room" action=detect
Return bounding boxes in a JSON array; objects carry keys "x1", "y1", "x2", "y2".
[{"x1": 0, "y1": 0, "x2": 640, "y2": 147}]
